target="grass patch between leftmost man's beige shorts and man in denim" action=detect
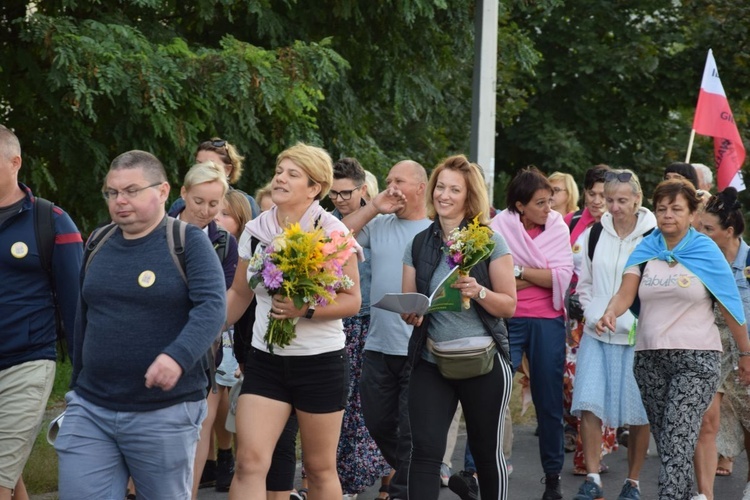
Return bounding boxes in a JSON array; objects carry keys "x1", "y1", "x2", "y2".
[{"x1": 23, "y1": 358, "x2": 73, "y2": 495}]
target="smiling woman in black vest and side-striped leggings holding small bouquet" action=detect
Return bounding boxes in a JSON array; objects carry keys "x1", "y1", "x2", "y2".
[{"x1": 402, "y1": 155, "x2": 516, "y2": 500}]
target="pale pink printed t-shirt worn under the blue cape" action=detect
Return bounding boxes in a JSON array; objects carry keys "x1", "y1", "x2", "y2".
[{"x1": 625, "y1": 260, "x2": 722, "y2": 351}]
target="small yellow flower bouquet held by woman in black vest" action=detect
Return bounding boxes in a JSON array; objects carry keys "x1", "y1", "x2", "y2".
[{"x1": 445, "y1": 217, "x2": 495, "y2": 309}]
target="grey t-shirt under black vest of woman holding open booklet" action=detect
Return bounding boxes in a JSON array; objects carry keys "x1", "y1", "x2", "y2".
[{"x1": 404, "y1": 233, "x2": 510, "y2": 363}]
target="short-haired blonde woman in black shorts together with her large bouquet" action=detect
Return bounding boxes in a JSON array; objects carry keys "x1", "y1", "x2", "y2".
[{"x1": 227, "y1": 143, "x2": 361, "y2": 500}]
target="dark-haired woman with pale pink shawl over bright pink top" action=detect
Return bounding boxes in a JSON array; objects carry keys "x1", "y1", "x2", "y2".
[{"x1": 491, "y1": 167, "x2": 573, "y2": 500}]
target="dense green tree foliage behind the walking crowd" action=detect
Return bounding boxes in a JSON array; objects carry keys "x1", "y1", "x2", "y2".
[{"x1": 0, "y1": 0, "x2": 750, "y2": 230}]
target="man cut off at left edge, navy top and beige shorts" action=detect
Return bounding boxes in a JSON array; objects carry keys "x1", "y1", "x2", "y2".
[{"x1": 0, "y1": 125, "x2": 83, "y2": 500}]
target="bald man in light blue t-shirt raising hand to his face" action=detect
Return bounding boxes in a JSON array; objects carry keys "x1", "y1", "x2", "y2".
[{"x1": 343, "y1": 160, "x2": 430, "y2": 500}]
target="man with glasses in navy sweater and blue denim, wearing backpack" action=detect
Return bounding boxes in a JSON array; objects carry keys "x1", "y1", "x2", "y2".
[{"x1": 55, "y1": 151, "x2": 226, "y2": 500}]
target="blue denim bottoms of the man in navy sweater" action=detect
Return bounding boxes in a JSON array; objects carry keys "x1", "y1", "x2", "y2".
[{"x1": 55, "y1": 391, "x2": 207, "y2": 500}]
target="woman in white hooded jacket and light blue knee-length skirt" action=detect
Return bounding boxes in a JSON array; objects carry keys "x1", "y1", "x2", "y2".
[{"x1": 571, "y1": 170, "x2": 656, "y2": 500}]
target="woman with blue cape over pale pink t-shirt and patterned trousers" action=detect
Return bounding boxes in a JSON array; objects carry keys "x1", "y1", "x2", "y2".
[{"x1": 596, "y1": 180, "x2": 750, "y2": 499}]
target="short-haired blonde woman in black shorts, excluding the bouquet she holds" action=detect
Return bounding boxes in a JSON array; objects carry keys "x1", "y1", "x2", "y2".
[{"x1": 227, "y1": 143, "x2": 361, "y2": 500}]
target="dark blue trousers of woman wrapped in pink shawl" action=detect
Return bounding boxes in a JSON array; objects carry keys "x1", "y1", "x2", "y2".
[{"x1": 508, "y1": 316, "x2": 565, "y2": 474}]
